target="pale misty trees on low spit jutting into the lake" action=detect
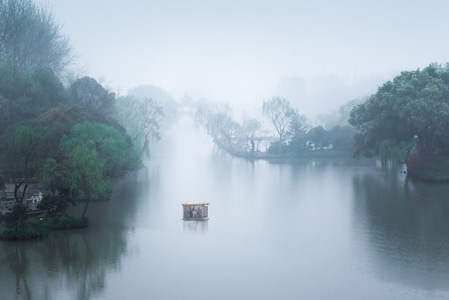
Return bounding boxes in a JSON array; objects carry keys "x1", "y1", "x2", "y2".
[{"x1": 196, "y1": 98, "x2": 355, "y2": 158}]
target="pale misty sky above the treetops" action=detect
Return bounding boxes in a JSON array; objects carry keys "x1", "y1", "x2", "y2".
[{"x1": 37, "y1": 0, "x2": 449, "y2": 116}]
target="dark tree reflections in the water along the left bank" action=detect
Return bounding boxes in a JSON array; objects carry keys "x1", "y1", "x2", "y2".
[{"x1": 0, "y1": 170, "x2": 151, "y2": 300}]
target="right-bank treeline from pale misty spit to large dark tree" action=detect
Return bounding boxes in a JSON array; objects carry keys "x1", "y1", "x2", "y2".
[{"x1": 196, "y1": 64, "x2": 449, "y2": 182}]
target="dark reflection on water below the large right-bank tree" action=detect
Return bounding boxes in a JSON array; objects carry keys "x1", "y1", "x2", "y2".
[{"x1": 353, "y1": 173, "x2": 449, "y2": 291}]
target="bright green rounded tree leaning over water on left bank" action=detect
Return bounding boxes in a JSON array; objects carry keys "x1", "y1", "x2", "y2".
[{"x1": 57, "y1": 122, "x2": 139, "y2": 217}]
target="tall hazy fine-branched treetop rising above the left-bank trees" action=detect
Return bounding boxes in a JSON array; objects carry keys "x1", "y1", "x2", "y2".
[{"x1": 0, "y1": 0, "x2": 73, "y2": 74}]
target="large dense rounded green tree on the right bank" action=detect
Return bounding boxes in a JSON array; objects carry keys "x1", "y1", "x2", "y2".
[{"x1": 349, "y1": 64, "x2": 449, "y2": 156}]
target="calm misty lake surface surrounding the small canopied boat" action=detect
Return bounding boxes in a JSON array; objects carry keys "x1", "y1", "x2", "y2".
[{"x1": 0, "y1": 120, "x2": 449, "y2": 300}]
